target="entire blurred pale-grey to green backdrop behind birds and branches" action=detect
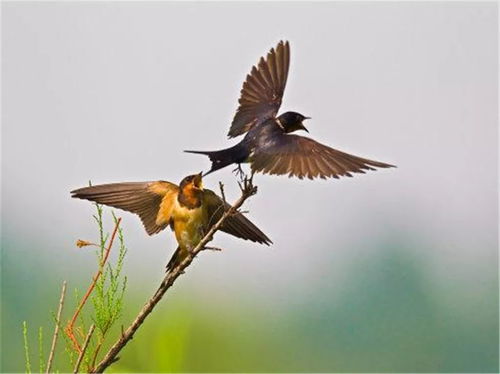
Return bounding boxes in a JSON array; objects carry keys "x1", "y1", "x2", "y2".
[{"x1": 0, "y1": 2, "x2": 499, "y2": 372}]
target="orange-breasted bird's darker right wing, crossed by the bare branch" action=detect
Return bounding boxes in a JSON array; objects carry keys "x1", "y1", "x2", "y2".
[{"x1": 203, "y1": 189, "x2": 272, "y2": 245}]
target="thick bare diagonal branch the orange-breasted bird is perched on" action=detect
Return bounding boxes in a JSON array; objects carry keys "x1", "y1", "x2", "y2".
[{"x1": 91, "y1": 179, "x2": 257, "y2": 373}]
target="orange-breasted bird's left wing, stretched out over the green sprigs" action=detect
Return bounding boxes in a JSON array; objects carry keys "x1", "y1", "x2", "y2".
[{"x1": 71, "y1": 181, "x2": 179, "y2": 235}]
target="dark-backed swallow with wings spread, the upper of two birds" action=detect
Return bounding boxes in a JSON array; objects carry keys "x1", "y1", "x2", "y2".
[{"x1": 185, "y1": 41, "x2": 393, "y2": 179}]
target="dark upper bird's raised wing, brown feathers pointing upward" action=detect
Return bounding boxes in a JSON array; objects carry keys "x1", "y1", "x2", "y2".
[{"x1": 228, "y1": 41, "x2": 290, "y2": 138}]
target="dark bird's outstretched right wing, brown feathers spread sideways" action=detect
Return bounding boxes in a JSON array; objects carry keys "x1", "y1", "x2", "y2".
[{"x1": 251, "y1": 134, "x2": 394, "y2": 179}]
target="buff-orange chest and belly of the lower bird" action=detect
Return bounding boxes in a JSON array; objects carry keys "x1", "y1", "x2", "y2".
[{"x1": 173, "y1": 203, "x2": 208, "y2": 249}]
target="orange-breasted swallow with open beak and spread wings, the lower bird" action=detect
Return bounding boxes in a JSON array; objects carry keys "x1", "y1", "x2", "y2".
[{"x1": 71, "y1": 173, "x2": 272, "y2": 270}]
